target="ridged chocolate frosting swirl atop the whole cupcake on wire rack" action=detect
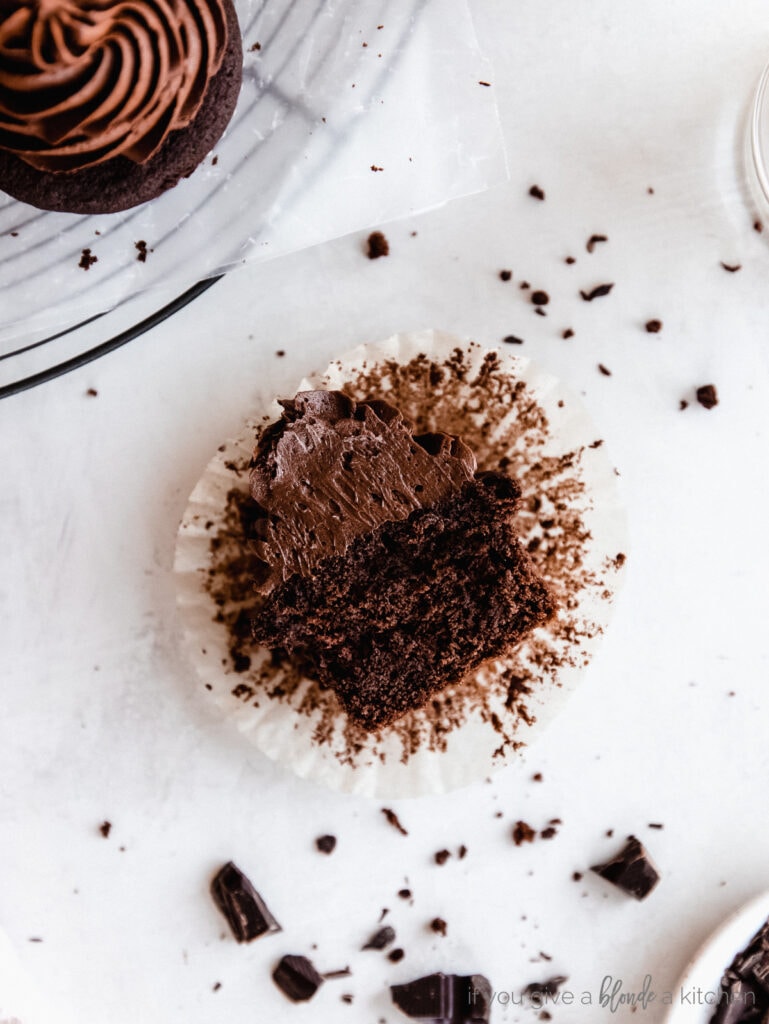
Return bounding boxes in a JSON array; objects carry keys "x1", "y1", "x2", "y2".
[{"x1": 0, "y1": 0, "x2": 227, "y2": 172}]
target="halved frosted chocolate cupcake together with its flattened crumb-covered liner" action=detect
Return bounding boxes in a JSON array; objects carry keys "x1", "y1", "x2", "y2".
[{"x1": 175, "y1": 332, "x2": 627, "y2": 797}]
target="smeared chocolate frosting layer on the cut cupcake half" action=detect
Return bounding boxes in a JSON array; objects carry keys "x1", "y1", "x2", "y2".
[{"x1": 250, "y1": 391, "x2": 475, "y2": 591}]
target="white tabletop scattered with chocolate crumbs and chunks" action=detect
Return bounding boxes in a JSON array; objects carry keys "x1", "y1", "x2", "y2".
[{"x1": 0, "y1": 0, "x2": 769, "y2": 1024}]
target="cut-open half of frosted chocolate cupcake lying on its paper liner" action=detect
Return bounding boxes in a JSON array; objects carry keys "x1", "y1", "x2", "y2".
[{"x1": 250, "y1": 391, "x2": 554, "y2": 731}]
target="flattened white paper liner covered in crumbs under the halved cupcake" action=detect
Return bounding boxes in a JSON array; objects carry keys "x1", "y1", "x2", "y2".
[{"x1": 174, "y1": 331, "x2": 627, "y2": 798}]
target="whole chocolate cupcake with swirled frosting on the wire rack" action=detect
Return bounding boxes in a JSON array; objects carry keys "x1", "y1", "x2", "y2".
[{"x1": 0, "y1": 0, "x2": 243, "y2": 214}]
